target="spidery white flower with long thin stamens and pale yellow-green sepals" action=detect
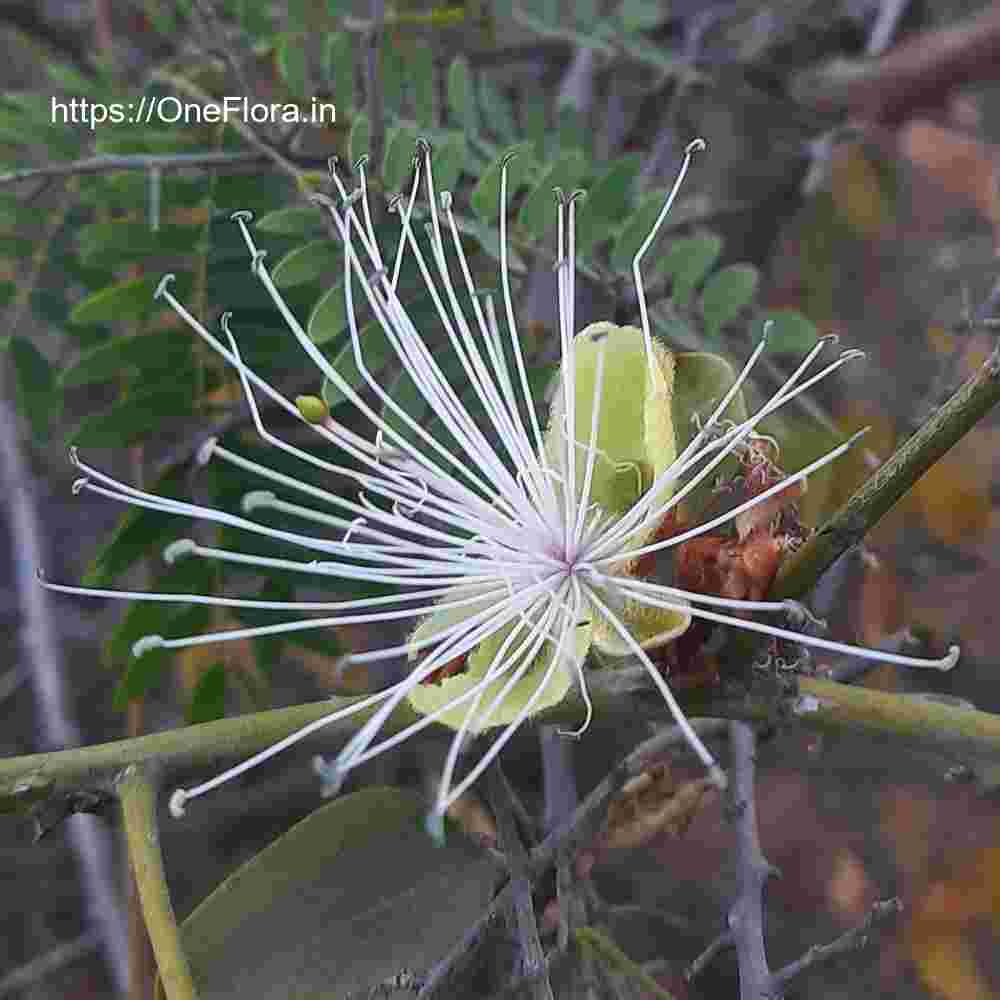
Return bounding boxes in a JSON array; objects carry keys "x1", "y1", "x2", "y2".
[{"x1": 41, "y1": 140, "x2": 958, "y2": 813}]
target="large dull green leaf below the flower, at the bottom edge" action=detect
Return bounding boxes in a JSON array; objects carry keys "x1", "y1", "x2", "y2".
[{"x1": 175, "y1": 788, "x2": 493, "y2": 1000}]
